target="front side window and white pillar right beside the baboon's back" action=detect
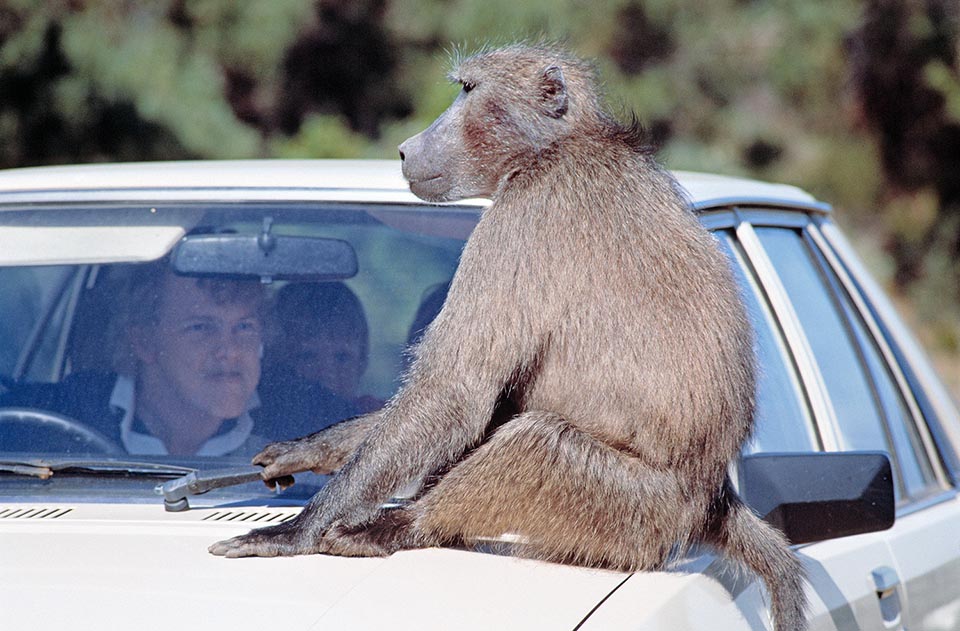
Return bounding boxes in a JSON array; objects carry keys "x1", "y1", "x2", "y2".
[{"x1": 717, "y1": 231, "x2": 819, "y2": 453}]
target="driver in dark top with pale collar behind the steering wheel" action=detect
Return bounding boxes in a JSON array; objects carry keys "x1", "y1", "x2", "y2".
[{"x1": 0, "y1": 260, "x2": 267, "y2": 456}]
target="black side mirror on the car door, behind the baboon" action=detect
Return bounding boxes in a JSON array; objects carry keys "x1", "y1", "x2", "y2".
[{"x1": 740, "y1": 452, "x2": 896, "y2": 543}]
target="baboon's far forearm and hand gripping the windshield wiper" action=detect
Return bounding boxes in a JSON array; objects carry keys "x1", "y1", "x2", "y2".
[{"x1": 253, "y1": 412, "x2": 381, "y2": 483}]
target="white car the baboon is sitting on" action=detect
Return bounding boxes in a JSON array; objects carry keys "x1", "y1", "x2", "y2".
[{"x1": 0, "y1": 161, "x2": 960, "y2": 631}]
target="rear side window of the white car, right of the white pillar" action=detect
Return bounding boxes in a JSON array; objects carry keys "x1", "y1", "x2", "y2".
[{"x1": 756, "y1": 227, "x2": 932, "y2": 504}]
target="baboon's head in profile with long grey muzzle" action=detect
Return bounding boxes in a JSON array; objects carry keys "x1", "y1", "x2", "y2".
[{"x1": 400, "y1": 46, "x2": 598, "y2": 202}]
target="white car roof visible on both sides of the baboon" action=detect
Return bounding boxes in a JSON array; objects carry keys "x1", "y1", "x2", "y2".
[{"x1": 0, "y1": 160, "x2": 829, "y2": 212}]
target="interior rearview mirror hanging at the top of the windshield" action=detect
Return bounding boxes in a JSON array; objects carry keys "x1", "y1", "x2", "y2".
[{"x1": 171, "y1": 231, "x2": 357, "y2": 281}]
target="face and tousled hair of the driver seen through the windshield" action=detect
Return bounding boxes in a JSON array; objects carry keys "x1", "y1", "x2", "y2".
[{"x1": 140, "y1": 274, "x2": 262, "y2": 419}]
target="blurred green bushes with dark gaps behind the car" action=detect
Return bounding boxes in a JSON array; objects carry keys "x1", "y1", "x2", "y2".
[{"x1": 0, "y1": 0, "x2": 960, "y2": 390}]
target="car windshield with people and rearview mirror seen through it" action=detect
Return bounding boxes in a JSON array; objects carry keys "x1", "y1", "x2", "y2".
[{"x1": 0, "y1": 203, "x2": 478, "y2": 504}]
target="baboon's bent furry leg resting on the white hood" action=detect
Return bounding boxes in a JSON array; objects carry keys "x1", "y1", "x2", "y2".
[{"x1": 406, "y1": 411, "x2": 707, "y2": 570}]
